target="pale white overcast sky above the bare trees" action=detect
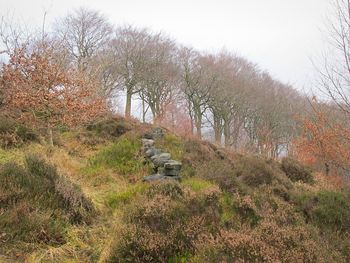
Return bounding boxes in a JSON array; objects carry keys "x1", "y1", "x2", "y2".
[{"x1": 0, "y1": 0, "x2": 331, "y2": 93}]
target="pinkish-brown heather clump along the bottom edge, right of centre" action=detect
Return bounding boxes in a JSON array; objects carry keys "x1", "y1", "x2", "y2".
[{"x1": 191, "y1": 221, "x2": 332, "y2": 262}]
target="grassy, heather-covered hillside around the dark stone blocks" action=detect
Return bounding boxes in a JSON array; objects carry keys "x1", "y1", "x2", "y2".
[{"x1": 0, "y1": 118, "x2": 350, "y2": 262}]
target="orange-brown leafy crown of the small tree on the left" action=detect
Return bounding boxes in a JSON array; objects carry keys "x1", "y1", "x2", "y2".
[{"x1": 0, "y1": 47, "x2": 106, "y2": 130}]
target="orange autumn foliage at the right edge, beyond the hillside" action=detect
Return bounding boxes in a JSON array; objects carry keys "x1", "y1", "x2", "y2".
[{"x1": 295, "y1": 110, "x2": 350, "y2": 174}]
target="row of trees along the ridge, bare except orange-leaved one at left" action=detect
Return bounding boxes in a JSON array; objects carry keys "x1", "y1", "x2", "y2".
[{"x1": 0, "y1": 8, "x2": 307, "y2": 157}]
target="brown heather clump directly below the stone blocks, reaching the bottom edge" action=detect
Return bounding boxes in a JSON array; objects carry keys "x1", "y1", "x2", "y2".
[{"x1": 108, "y1": 183, "x2": 220, "y2": 262}]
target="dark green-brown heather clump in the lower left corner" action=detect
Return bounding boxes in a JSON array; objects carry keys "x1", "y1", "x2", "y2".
[{"x1": 0, "y1": 163, "x2": 67, "y2": 252}]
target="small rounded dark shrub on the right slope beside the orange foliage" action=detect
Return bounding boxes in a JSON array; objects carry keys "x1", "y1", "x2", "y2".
[{"x1": 281, "y1": 158, "x2": 313, "y2": 183}]
